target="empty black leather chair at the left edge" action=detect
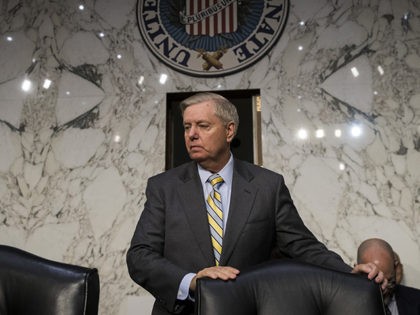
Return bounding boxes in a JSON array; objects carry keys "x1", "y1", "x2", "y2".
[{"x1": 0, "y1": 245, "x2": 99, "y2": 315}]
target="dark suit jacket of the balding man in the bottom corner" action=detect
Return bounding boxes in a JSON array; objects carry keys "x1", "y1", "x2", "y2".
[{"x1": 395, "y1": 285, "x2": 420, "y2": 315}]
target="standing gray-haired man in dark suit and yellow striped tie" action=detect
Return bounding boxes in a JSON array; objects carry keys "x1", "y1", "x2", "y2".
[{"x1": 127, "y1": 93, "x2": 384, "y2": 315}]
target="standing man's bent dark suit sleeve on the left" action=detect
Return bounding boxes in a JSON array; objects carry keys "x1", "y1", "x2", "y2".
[{"x1": 127, "y1": 179, "x2": 188, "y2": 312}]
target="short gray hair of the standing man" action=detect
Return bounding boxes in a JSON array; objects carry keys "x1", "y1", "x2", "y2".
[{"x1": 179, "y1": 92, "x2": 239, "y2": 134}]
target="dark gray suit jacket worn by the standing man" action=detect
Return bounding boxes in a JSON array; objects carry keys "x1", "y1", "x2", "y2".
[{"x1": 127, "y1": 159, "x2": 351, "y2": 315}]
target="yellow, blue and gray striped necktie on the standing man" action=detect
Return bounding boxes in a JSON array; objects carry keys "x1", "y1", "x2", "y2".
[{"x1": 206, "y1": 174, "x2": 223, "y2": 266}]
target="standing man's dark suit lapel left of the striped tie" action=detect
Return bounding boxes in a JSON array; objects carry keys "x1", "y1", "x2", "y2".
[{"x1": 177, "y1": 163, "x2": 214, "y2": 266}]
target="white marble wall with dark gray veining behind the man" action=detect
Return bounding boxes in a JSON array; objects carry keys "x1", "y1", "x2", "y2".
[{"x1": 0, "y1": 0, "x2": 420, "y2": 314}]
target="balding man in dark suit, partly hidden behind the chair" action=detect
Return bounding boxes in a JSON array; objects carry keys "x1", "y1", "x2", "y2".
[{"x1": 357, "y1": 238, "x2": 420, "y2": 315}]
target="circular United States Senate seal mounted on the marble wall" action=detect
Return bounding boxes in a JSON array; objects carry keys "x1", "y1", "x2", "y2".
[{"x1": 137, "y1": 0, "x2": 289, "y2": 77}]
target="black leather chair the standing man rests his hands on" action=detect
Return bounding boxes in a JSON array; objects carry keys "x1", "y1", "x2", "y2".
[{"x1": 195, "y1": 260, "x2": 385, "y2": 315}]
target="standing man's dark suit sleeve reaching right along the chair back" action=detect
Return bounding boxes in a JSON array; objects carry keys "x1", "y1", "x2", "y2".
[{"x1": 276, "y1": 176, "x2": 352, "y2": 272}]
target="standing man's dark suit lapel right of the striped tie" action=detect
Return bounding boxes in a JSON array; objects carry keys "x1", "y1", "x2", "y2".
[{"x1": 220, "y1": 160, "x2": 257, "y2": 265}]
